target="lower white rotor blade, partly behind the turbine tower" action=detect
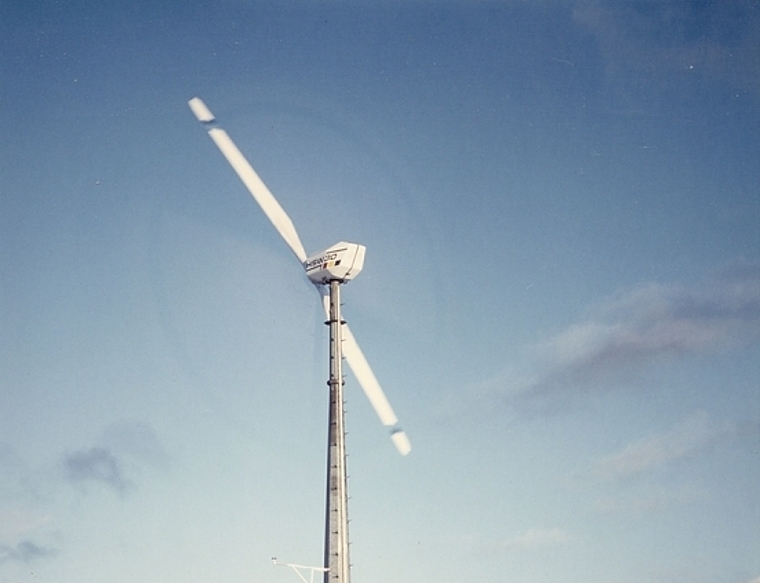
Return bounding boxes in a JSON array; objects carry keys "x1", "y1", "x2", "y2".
[{"x1": 318, "y1": 286, "x2": 412, "y2": 455}]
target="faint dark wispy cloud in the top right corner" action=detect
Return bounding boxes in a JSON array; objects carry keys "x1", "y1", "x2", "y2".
[{"x1": 571, "y1": 0, "x2": 760, "y2": 101}]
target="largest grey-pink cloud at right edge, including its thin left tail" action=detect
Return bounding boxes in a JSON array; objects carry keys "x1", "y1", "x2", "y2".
[{"x1": 469, "y1": 264, "x2": 760, "y2": 408}]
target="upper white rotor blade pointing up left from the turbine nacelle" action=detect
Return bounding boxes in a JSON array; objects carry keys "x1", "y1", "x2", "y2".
[{"x1": 188, "y1": 97, "x2": 306, "y2": 263}]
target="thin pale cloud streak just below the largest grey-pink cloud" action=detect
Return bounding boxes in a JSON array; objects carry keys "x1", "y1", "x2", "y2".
[{"x1": 592, "y1": 411, "x2": 735, "y2": 480}]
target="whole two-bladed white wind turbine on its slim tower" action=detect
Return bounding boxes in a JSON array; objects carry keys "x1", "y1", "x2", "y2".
[{"x1": 188, "y1": 97, "x2": 412, "y2": 583}]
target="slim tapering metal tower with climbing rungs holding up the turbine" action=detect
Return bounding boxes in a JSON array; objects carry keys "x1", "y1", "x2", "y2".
[{"x1": 324, "y1": 279, "x2": 351, "y2": 583}]
